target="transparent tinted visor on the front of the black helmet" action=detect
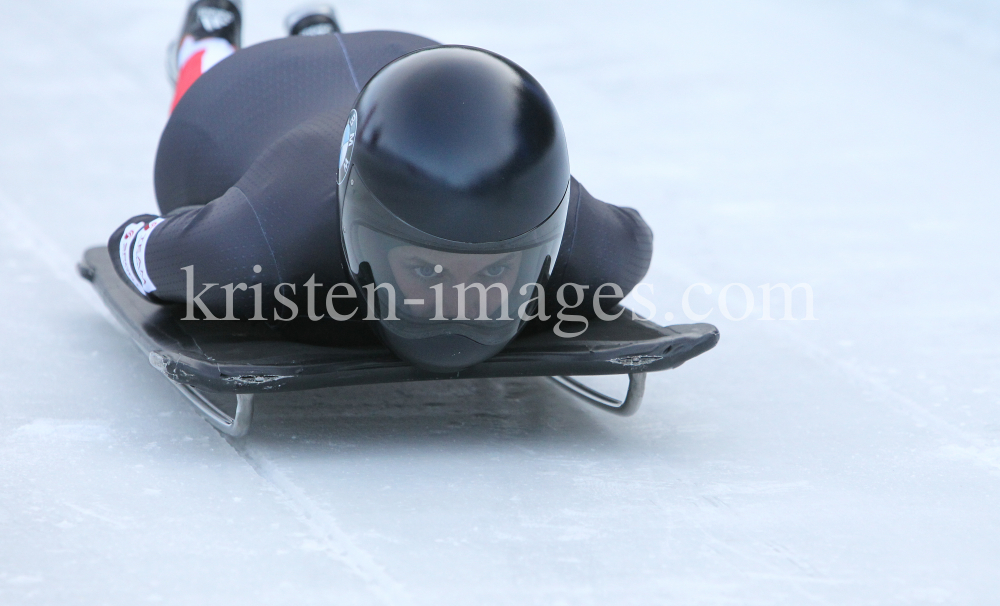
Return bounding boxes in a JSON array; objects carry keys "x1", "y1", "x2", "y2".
[{"x1": 341, "y1": 168, "x2": 569, "y2": 345}]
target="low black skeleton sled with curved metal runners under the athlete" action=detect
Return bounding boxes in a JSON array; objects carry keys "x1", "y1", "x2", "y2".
[{"x1": 79, "y1": 247, "x2": 719, "y2": 437}]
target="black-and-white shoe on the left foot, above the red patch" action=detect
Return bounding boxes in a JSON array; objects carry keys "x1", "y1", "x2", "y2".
[{"x1": 167, "y1": 0, "x2": 243, "y2": 83}]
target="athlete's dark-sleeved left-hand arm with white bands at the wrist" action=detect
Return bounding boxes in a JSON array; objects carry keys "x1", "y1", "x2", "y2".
[{"x1": 108, "y1": 122, "x2": 346, "y2": 319}]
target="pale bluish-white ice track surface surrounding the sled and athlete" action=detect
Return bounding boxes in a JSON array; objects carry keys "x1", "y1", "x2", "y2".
[{"x1": 0, "y1": 0, "x2": 1000, "y2": 605}]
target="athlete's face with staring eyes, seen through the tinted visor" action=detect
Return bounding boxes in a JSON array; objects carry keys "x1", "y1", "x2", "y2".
[{"x1": 389, "y1": 246, "x2": 522, "y2": 319}]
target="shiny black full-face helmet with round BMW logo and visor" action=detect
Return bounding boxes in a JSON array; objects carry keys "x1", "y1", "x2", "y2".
[{"x1": 338, "y1": 46, "x2": 570, "y2": 372}]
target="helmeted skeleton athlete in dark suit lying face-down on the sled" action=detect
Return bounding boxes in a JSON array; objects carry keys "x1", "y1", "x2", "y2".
[{"x1": 108, "y1": 0, "x2": 652, "y2": 372}]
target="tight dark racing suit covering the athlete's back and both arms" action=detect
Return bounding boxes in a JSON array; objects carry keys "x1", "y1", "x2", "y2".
[{"x1": 108, "y1": 32, "x2": 652, "y2": 319}]
